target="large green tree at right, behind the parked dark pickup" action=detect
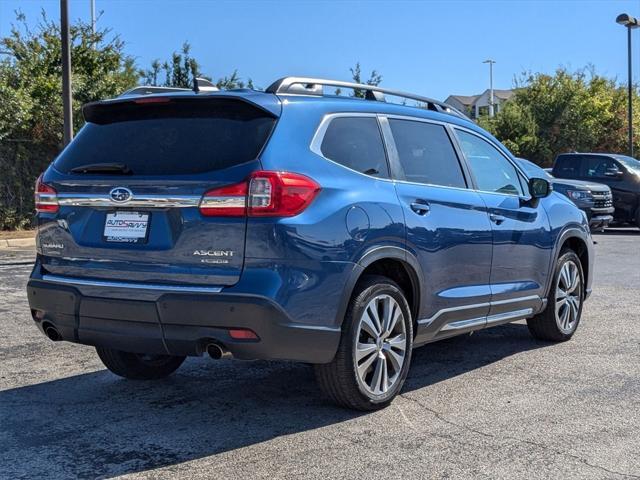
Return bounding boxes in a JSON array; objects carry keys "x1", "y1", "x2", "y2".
[{"x1": 479, "y1": 68, "x2": 640, "y2": 166}]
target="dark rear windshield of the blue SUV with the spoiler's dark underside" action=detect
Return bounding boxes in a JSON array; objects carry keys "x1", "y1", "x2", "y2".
[{"x1": 54, "y1": 99, "x2": 276, "y2": 175}]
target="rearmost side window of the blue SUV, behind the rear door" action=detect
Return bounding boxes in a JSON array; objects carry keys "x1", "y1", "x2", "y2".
[{"x1": 320, "y1": 117, "x2": 389, "y2": 178}]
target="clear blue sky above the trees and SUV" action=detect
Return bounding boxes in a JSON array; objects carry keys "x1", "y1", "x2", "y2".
[{"x1": 0, "y1": 0, "x2": 640, "y2": 99}]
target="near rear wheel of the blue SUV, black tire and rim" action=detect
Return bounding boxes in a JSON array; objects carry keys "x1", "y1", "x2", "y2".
[{"x1": 315, "y1": 275, "x2": 413, "y2": 411}]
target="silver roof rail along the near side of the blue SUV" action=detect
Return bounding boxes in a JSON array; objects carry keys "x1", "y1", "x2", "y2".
[{"x1": 265, "y1": 77, "x2": 469, "y2": 120}]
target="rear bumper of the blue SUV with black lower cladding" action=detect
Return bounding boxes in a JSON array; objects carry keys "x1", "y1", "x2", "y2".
[{"x1": 27, "y1": 275, "x2": 340, "y2": 363}]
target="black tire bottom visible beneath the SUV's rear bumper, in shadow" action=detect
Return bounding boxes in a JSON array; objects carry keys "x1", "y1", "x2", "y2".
[{"x1": 96, "y1": 347, "x2": 185, "y2": 380}]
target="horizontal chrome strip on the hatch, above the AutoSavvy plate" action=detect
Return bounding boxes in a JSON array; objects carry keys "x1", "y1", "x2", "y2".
[{"x1": 58, "y1": 193, "x2": 201, "y2": 208}]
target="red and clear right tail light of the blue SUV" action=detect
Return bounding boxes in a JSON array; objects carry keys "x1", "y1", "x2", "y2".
[{"x1": 200, "y1": 171, "x2": 320, "y2": 217}]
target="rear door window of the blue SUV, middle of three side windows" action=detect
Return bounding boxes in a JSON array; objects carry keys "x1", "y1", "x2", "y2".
[{"x1": 389, "y1": 119, "x2": 466, "y2": 188}]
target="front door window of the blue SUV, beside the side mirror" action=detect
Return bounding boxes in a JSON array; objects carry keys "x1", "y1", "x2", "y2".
[{"x1": 457, "y1": 130, "x2": 524, "y2": 195}]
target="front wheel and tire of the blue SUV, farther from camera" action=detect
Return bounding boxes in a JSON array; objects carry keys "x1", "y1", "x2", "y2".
[{"x1": 527, "y1": 250, "x2": 584, "y2": 342}]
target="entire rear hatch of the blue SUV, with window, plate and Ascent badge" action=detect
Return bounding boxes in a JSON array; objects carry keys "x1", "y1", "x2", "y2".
[{"x1": 39, "y1": 94, "x2": 279, "y2": 285}]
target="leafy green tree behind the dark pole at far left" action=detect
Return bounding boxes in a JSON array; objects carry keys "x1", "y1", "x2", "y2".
[{"x1": 0, "y1": 13, "x2": 138, "y2": 229}]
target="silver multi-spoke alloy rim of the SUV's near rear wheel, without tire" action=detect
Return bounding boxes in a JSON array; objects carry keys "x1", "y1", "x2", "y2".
[{"x1": 353, "y1": 294, "x2": 407, "y2": 395}]
